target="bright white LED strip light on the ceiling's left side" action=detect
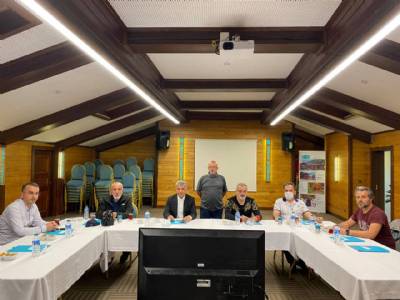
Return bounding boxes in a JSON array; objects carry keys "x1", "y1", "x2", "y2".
[{"x1": 17, "y1": 0, "x2": 179, "y2": 124}]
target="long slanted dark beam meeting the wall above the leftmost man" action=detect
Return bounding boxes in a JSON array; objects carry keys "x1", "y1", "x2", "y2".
[{"x1": 0, "y1": 88, "x2": 137, "y2": 144}]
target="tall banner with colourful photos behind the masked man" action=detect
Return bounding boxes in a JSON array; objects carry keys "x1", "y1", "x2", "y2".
[{"x1": 299, "y1": 151, "x2": 326, "y2": 213}]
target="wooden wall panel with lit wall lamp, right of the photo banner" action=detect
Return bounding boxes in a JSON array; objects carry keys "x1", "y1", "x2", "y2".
[{"x1": 325, "y1": 133, "x2": 350, "y2": 218}]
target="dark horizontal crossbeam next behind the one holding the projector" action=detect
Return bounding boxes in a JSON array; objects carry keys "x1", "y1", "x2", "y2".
[{"x1": 161, "y1": 79, "x2": 287, "y2": 92}]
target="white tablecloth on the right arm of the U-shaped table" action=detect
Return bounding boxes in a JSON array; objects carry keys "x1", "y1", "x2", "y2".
[{"x1": 293, "y1": 228, "x2": 400, "y2": 300}]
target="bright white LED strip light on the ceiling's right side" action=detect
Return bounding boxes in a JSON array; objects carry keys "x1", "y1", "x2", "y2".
[{"x1": 271, "y1": 14, "x2": 400, "y2": 126}]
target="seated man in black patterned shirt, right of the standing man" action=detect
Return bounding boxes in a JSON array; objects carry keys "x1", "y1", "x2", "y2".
[{"x1": 225, "y1": 183, "x2": 261, "y2": 222}]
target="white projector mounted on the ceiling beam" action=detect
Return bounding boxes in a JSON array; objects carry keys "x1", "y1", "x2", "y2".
[{"x1": 218, "y1": 32, "x2": 254, "y2": 55}]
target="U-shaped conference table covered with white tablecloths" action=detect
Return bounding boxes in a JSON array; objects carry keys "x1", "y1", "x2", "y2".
[{"x1": 0, "y1": 218, "x2": 400, "y2": 300}]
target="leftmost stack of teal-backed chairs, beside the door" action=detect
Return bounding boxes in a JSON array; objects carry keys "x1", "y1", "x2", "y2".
[{"x1": 64, "y1": 164, "x2": 86, "y2": 213}]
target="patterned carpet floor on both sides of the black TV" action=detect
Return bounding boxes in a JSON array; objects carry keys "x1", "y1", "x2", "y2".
[{"x1": 62, "y1": 209, "x2": 343, "y2": 300}]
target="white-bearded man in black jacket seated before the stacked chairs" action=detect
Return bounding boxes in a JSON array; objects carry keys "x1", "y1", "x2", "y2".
[{"x1": 96, "y1": 181, "x2": 137, "y2": 269}]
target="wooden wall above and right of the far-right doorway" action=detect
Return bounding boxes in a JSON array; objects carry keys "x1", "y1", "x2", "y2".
[{"x1": 371, "y1": 130, "x2": 400, "y2": 219}]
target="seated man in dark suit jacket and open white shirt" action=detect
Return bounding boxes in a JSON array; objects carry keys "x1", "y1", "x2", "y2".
[{"x1": 164, "y1": 180, "x2": 197, "y2": 223}]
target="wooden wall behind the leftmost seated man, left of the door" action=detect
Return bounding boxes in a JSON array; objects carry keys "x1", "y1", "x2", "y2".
[{"x1": 5, "y1": 141, "x2": 52, "y2": 206}]
